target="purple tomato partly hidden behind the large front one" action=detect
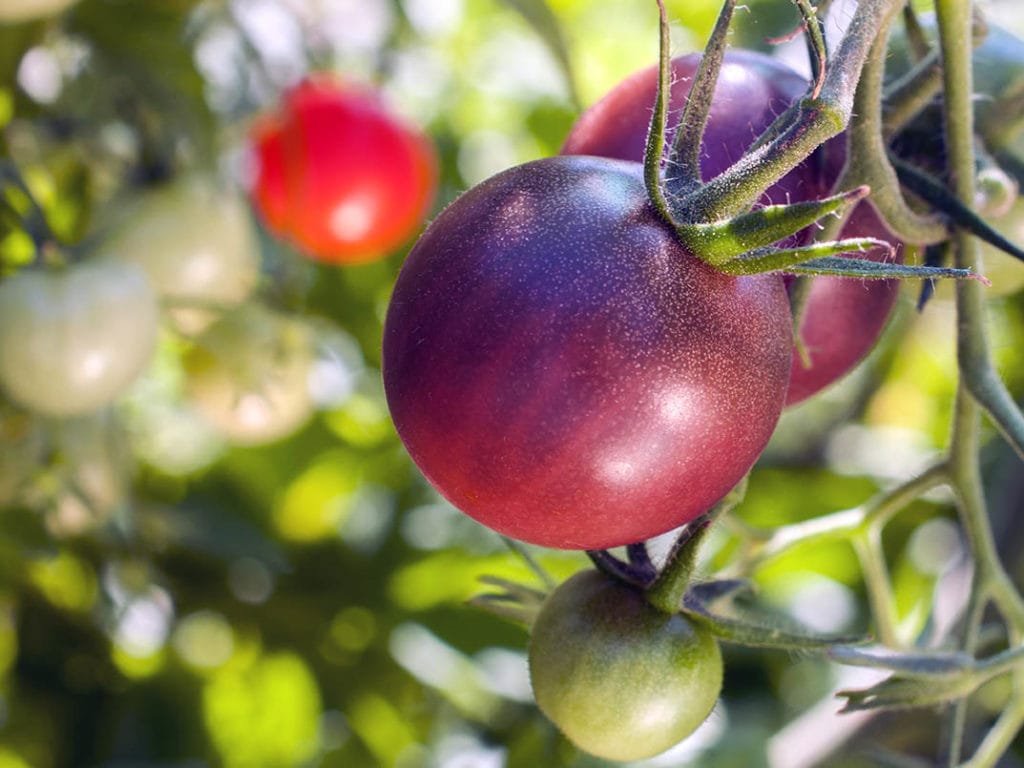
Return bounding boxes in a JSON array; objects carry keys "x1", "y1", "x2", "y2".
[{"x1": 562, "y1": 50, "x2": 898, "y2": 406}]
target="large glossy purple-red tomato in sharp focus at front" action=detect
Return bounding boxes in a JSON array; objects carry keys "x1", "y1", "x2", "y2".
[{"x1": 383, "y1": 156, "x2": 792, "y2": 549}]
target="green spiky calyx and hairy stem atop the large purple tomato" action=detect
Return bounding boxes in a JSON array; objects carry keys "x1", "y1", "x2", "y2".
[{"x1": 644, "y1": 0, "x2": 991, "y2": 282}]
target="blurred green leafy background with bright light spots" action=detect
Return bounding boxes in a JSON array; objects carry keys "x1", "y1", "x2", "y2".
[{"x1": 0, "y1": 0, "x2": 1024, "y2": 768}]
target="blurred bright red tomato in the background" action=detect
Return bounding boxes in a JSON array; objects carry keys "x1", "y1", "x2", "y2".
[{"x1": 251, "y1": 75, "x2": 437, "y2": 264}]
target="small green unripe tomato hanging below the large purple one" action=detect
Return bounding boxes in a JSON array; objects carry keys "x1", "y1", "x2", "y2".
[{"x1": 529, "y1": 570, "x2": 722, "y2": 761}]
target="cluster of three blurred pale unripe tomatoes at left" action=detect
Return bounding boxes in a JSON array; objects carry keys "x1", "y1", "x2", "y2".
[{"x1": 0, "y1": 174, "x2": 314, "y2": 444}]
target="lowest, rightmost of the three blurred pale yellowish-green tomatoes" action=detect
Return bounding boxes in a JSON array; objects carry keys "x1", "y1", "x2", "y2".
[{"x1": 184, "y1": 305, "x2": 314, "y2": 445}]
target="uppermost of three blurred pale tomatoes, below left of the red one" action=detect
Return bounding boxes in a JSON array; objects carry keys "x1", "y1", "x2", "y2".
[{"x1": 106, "y1": 174, "x2": 260, "y2": 334}]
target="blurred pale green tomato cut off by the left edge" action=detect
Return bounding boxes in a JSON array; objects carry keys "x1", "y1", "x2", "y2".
[{"x1": 0, "y1": 260, "x2": 159, "y2": 417}]
